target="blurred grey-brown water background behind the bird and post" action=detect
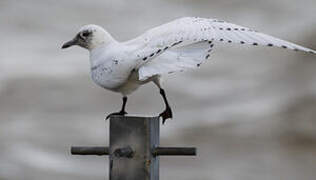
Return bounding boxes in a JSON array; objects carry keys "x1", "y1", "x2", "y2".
[{"x1": 0, "y1": 0, "x2": 316, "y2": 180}]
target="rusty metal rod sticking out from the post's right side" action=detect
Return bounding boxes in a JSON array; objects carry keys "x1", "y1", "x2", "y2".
[{"x1": 152, "y1": 147, "x2": 196, "y2": 156}]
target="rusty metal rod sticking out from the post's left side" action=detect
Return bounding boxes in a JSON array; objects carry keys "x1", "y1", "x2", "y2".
[{"x1": 71, "y1": 146, "x2": 109, "y2": 156}]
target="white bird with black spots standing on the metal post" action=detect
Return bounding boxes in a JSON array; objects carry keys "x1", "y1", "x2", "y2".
[{"x1": 62, "y1": 17, "x2": 316, "y2": 123}]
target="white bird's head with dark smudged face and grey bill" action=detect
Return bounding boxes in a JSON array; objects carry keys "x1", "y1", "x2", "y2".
[{"x1": 62, "y1": 24, "x2": 113, "y2": 50}]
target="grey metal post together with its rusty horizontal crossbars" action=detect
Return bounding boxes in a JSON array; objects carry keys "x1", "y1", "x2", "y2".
[{"x1": 71, "y1": 116, "x2": 196, "y2": 180}]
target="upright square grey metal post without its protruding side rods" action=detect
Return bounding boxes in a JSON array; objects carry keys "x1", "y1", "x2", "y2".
[{"x1": 110, "y1": 116, "x2": 159, "y2": 180}]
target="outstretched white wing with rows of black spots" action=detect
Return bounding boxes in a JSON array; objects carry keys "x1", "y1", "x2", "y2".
[{"x1": 125, "y1": 17, "x2": 316, "y2": 80}]
